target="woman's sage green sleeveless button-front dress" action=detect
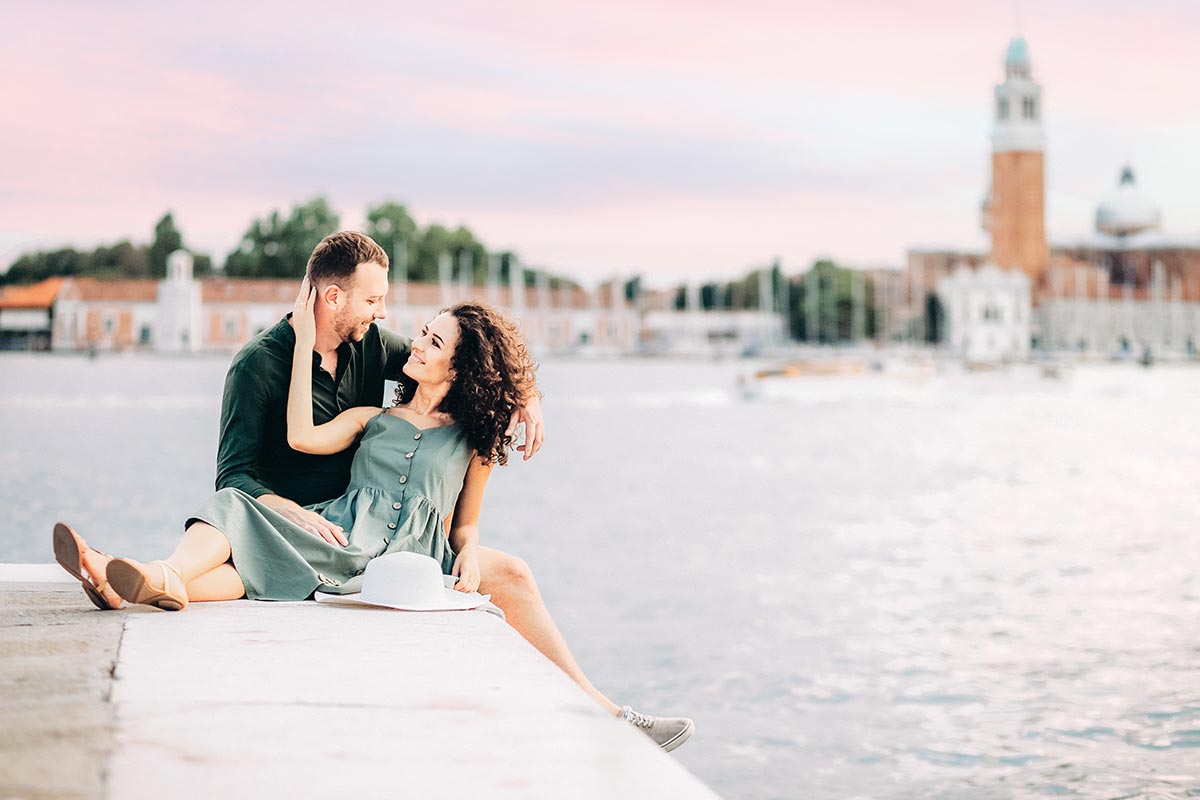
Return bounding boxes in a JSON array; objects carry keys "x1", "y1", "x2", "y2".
[{"x1": 187, "y1": 413, "x2": 474, "y2": 600}]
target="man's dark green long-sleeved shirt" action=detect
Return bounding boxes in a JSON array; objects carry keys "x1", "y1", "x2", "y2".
[{"x1": 217, "y1": 318, "x2": 410, "y2": 505}]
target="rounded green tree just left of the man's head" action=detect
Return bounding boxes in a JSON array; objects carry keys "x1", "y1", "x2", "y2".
[{"x1": 226, "y1": 197, "x2": 340, "y2": 278}]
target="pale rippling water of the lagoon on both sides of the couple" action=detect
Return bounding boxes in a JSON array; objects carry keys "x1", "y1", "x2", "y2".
[{"x1": 0, "y1": 355, "x2": 1200, "y2": 800}]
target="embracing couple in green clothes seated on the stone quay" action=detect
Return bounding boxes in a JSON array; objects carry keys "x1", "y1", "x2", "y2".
[{"x1": 54, "y1": 231, "x2": 692, "y2": 751}]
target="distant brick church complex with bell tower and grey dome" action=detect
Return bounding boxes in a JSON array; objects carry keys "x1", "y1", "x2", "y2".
[{"x1": 884, "y1": 37, "x2": 1200, "y2": 354}]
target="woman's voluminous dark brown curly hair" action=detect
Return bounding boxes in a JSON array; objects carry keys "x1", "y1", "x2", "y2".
[{"x1": 396, "y1": 300, "x2": 540, "y2": 464}]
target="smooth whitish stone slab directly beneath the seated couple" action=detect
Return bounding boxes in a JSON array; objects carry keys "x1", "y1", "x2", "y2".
[{"x1": 109, "y1": 601, "x2": 714, "y2": 799}]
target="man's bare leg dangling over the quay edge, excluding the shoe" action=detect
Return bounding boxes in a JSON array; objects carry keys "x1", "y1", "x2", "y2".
[{"x1": 479, "y1": 547, "x2": 620, "y2": 716}]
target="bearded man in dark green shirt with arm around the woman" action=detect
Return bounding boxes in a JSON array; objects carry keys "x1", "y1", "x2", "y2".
[{"x1": 216, "y1": 230, "x2": 692, "y2": 751}]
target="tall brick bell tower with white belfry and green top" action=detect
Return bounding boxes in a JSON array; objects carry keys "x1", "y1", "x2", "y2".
[{"x1": 983, "y1": 36, "x2": 1050, "y2": 287}]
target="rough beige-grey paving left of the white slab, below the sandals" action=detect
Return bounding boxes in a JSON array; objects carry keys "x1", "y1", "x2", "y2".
[{"x1": 0, "y1": 575, "x2": 125, "y2": 799}]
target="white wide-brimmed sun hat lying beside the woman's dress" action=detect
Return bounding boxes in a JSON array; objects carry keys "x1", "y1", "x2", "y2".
[{"x1": 317, "y1": 553, "x2": 491, "y2": 612}]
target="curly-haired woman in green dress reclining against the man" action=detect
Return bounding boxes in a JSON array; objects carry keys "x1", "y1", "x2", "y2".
[{"x1": 54, "y1": 281, "x2": 534, "y2": 610}]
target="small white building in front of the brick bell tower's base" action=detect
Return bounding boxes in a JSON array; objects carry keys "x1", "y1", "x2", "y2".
[{"x1": 937, "y1": 264, "x2": 1032, "y2": 363}]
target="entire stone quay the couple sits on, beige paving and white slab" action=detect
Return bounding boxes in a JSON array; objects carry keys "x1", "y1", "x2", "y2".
[{"x1": 0, "y1": 565, "x2": 716, "y2": 799}]
